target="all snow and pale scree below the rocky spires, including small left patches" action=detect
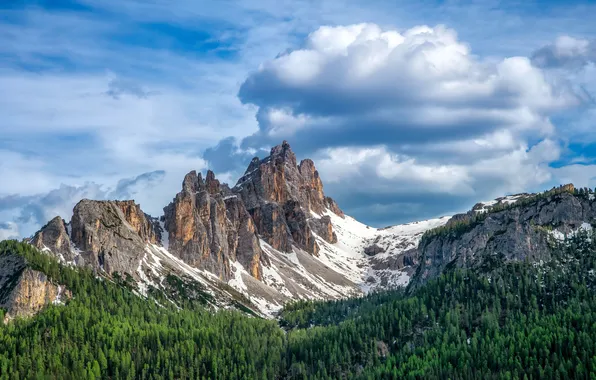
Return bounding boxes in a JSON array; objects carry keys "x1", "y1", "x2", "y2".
[{"x1": 30, "y1": 209, "x2": 447, "y2": 317}]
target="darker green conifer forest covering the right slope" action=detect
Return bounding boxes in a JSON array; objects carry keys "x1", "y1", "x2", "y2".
[{"x1": 282, "y1": 233, "x2": 596, "y2": 379}]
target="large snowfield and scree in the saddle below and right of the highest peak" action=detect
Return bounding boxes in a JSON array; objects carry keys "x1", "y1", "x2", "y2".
[{"x1": 203, "y1": 210, "x2": 449, "y2": 315}]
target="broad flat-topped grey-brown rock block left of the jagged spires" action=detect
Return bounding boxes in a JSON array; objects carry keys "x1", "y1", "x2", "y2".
[{"x1": 71, "y1": 199, "x2": 156, "y2": 277}]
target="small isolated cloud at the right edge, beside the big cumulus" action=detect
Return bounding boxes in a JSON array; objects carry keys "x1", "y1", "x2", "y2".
[{"x1": 532, "y1": 36, "x2": 596, "y2": 69}]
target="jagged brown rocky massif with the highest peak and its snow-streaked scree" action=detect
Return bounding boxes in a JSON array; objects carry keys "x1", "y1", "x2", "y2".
[{"x1": 25, "y1": 141, "x2": 357, "y2": 314}]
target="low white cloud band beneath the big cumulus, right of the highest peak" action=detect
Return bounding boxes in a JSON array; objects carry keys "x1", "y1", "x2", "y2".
[{"x1": 316, "y1": 140, "x2": 560, "y2": 197}]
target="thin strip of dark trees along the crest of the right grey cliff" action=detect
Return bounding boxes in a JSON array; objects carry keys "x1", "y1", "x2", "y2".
[{"x1": 420, "y1": 184, "x2": 594, "y2": 245}]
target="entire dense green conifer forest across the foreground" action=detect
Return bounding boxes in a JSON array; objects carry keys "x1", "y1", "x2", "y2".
[{"x1": 0, "y1": 230, "x2": 596, "y2": 379}]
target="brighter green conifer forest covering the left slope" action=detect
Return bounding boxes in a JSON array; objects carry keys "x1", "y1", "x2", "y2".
[{"x1": 0, "y1": 241, "x2": 285, "y2": 380}]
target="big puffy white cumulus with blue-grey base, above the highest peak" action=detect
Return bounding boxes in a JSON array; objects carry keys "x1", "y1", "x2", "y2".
[{"x1": 239, "y1": 24, "x2": 577, "y2": 153}]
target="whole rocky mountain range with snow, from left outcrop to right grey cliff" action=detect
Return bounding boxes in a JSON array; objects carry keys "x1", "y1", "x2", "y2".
[{"x1": 0, "y1": 141, "x2": 596, "y2": 320}]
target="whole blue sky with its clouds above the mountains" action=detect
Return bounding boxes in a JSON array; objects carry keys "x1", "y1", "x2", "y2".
[{"x1": 0, "y1": 0, "x2": 596, "y2": 239}]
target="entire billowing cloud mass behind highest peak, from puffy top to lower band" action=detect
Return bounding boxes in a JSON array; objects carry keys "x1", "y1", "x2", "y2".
[{"x1": 197, "y1": 24, "x2": 583, "y2": 225}]
